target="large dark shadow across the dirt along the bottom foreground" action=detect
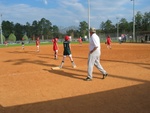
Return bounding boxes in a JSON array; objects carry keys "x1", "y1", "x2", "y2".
[{"x1": 0, "y1": 82, "x2": 150, "y2": 113}]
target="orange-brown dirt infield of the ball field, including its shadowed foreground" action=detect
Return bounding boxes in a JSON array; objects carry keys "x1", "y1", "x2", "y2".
[{"x1": 0, "y1": 43, "x2": 150, "y2": 113}]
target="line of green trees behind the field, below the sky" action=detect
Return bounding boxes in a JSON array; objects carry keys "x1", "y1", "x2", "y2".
[{"x1": 0, "y1": 11, "x2": 150, "y2": 42}]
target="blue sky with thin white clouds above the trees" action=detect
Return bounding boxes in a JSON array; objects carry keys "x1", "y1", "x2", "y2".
[{"x1": 0, "y1": 0, "x2": 150, "y2": 28}]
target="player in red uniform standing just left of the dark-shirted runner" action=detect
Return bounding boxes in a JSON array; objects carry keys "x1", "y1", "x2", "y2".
[{"x1": 52, "y1": 37, "x2": 58, "y2": 59}]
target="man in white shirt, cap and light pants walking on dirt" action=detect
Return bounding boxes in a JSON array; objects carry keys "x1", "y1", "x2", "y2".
[{"x1": 85, "y1": 28, "x2": 108, "y2": 81}]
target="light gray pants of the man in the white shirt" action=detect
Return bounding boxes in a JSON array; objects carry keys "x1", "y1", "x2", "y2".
[{"x1": 87, "y1": 54, "x2": 106, "y2": 79}]
